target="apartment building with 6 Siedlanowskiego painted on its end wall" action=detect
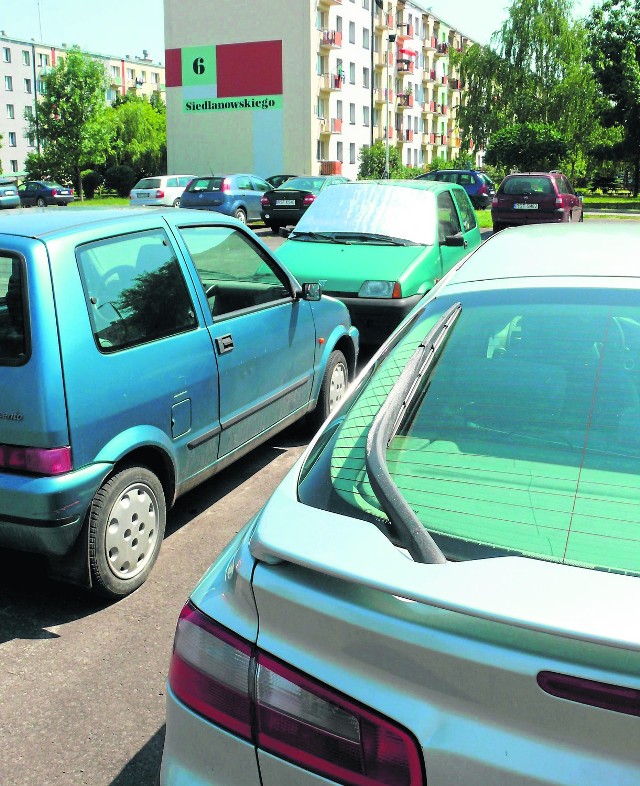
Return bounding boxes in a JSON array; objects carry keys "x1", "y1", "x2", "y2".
[{"x1": 164, "y1": 0, "x2": 471, "y2": 179}]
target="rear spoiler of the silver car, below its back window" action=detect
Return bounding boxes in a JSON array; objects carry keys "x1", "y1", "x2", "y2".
[{"x1": 250, "y1": 454, "x2": 640, "y2": 652}]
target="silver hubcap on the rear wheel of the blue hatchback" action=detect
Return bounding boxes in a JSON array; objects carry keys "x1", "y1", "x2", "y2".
[{"x1": 104, "y1": 483, "x2": 158, "y2": 579}]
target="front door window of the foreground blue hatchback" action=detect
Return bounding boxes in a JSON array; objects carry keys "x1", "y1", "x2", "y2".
[{"x1": 180, "y1": 226, "x2": 291, "y2": 319}]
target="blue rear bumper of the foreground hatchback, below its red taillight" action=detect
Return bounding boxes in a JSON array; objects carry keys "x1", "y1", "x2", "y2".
[{"x1": 0, "y1": 464, "x2": 112, "y2": 556}]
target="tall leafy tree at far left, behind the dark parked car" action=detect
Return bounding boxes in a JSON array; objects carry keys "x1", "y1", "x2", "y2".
[{"x1": 27, "y1": 49, "x2": 110, "y2": 199}]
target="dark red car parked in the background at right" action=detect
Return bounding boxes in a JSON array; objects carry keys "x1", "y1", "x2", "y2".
[{"x1": 491, "y1": 172, "x2": 584, "y2": 232}]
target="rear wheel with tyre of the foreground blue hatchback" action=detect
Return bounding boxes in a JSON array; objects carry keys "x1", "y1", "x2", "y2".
[{"x1": 89, "y1": 466, "x2": 166, "y2": 598}]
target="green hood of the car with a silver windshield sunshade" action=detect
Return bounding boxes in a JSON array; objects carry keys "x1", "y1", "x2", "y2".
[{"x1": 276, "y1": 240, "x2": 430, "y2": 294}]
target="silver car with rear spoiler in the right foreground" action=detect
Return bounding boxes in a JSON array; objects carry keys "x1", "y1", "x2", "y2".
[{"x1": 160, "y1": 222, "x2": 640, "y2": 786}]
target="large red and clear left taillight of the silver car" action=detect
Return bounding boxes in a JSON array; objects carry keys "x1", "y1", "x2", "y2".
[{"x1": 169, "y1": 604, "x2": 424, "y2": 786}]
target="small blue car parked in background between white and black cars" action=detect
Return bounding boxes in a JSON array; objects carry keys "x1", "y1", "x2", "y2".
[{"x1": 180, "y1": 174, "x2": 273, "y2": 224}]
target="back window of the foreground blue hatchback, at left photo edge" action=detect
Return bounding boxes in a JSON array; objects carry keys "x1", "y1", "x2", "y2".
[{"x1": 0, "y1": 254, "x2": 28, "y2": 365}]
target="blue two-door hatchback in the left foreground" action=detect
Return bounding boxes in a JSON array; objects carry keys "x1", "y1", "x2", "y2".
[{"x1": 0, "y1": 208, "x2": 358, "y2": 597}]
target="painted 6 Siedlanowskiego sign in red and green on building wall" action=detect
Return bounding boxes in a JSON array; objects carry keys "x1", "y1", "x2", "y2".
[{"x1": 166, "y1": 41, "x2": 282, "y2": 113}]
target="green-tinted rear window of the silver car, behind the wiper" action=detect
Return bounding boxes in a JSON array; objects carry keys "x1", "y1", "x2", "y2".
[{"x1": 299, "y1": 290, "x2": 640, "y2": 575}]
